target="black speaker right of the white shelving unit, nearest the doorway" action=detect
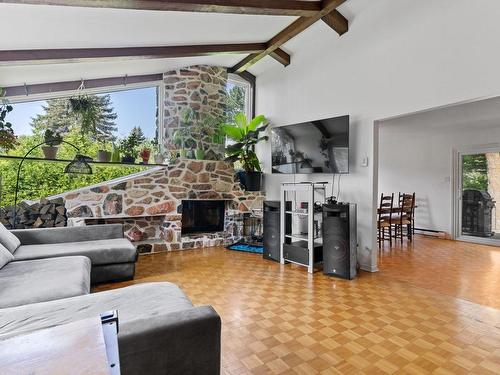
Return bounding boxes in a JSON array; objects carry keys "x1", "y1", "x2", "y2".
[{"x1": 323, "y1": 203, "x2": 358, "y2": 280}]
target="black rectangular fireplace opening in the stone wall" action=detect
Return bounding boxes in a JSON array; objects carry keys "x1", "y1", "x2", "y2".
[{"x1": 181, "y1": 200, "x2": 226, "y2": 234}]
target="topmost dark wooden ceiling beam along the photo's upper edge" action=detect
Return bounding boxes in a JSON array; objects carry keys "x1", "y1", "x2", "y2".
[{"x1": 0, "y1": 0, "x2": 322, "y2": 17}]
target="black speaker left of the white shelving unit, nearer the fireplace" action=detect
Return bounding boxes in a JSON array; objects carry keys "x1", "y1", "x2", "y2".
[{"x1": 262, "y1": 201, "x2": 291, "y2": 262}]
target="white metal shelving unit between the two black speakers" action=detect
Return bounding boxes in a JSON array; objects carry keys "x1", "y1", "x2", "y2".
[{"x1": 280, "y1": 182, "x2": 328, "y2": 273}]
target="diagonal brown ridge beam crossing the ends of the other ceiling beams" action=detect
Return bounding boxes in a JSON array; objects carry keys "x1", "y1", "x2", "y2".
[{"x1": 233, "y1": 0, "x2": 346, "y2": 73}]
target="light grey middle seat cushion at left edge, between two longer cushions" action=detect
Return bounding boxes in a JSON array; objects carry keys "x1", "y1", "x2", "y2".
[{"x1": 0, "y1": 256, "x2": 90, "y2": 310}]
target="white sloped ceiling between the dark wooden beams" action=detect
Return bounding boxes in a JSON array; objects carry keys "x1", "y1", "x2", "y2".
[{"x1": 0, "y1": 0, "x2": 356, "y2": 86}]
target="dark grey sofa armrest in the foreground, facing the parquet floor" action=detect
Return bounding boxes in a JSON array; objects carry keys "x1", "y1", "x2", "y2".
[{"x1": 118, "y1": 306, "x2": 221, "y2": 375}]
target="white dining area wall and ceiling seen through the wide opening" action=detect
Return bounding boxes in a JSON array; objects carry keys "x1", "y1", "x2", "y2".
[{"x1": 378, "y1": 98, "x2": 500, "y2": 234}]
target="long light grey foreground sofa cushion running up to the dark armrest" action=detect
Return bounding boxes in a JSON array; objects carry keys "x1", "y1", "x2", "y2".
[{"x1": 0, "y1": 284, "x2": 193, "y2": 339}]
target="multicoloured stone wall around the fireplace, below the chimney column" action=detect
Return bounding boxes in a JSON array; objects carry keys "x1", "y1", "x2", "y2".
[{"x1": 63, "y1": 159, "x2": 264, "y2": 251}]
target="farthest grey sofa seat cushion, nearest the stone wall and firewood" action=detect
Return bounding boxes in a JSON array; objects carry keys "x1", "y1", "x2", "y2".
[{"x1": 14, "y1": 238, "x2": 137, "y2": 265}]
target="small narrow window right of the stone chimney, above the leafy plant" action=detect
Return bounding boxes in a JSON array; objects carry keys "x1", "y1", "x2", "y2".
[{"x1": 227, "y1": 74, "x2": 253, "y2": 123}]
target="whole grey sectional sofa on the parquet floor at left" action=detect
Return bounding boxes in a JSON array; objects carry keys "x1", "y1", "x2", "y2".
[{"x1": 0, "y1": 224, "x2": 221, "y2": 375}]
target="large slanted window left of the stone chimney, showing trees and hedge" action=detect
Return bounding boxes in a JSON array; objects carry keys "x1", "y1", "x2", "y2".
[{"x1": 0, "y1": 86, "x2": 161, "y2": 206}]
